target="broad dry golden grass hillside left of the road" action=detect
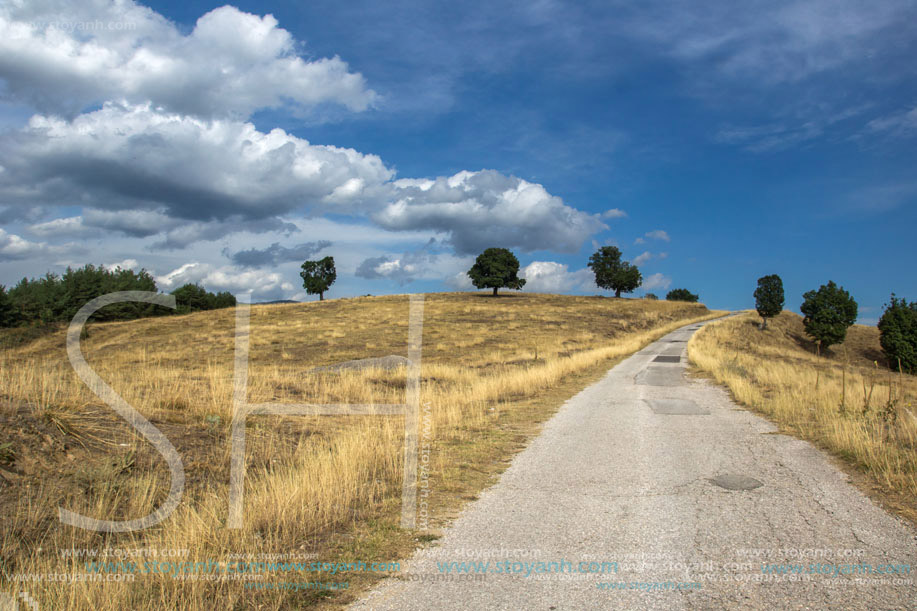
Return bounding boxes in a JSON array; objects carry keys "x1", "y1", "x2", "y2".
[{"x1": 0, "y1": 293, "x2": 716, "y2": 610}]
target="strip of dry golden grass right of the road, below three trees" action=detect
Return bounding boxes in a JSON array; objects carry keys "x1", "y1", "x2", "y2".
[{"x1": 688, "y1": 312, "x2": 917, "y2": 522}]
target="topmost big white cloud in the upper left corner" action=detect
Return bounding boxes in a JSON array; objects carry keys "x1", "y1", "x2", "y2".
[{"x1": 0, "y1": 0, "x2": 376, "y2": 118}]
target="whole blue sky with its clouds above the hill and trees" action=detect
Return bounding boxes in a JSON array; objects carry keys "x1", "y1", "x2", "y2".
[{"x1": 0, "y1": 0, "x2": 917, "y2": 323}]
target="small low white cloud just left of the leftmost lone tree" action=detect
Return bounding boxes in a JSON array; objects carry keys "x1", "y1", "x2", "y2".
[{"x1": 156, "y1": 262, "x2": 295, "y2": 298}]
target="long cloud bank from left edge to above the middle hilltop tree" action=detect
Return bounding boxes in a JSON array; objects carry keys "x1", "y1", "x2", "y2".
[{"x1": 0, "y1": 103, "x2": 607, "y2": 255}]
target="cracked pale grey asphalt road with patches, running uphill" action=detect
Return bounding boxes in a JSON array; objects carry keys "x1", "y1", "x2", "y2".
[{"x1": 353, "y1": 318, "x2": 917, "y2": 611}]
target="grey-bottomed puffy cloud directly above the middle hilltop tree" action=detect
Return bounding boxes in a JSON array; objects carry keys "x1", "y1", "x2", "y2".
[{"x1": 372, "y1": 170, "x2": 608, "y2": 254}]
